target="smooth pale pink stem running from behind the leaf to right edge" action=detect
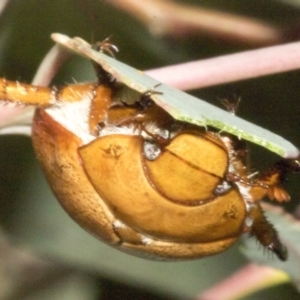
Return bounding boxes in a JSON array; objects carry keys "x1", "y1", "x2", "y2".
[{"x1": 146, "y1": 42, "x2": 300, "y2": 90}]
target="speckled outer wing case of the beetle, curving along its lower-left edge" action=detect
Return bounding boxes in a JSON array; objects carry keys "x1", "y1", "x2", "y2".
[{"x1": 32, "y1": 109, "x2": 244, "y2": 260}]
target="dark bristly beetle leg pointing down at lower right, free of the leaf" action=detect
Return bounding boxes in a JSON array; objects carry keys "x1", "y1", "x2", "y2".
[{"x1": 250, "y1": 203, "x2": 287, "y2": 261}]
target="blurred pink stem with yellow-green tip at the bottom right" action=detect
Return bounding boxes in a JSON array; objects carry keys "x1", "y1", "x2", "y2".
[{"x1": 195, "y1": 263, "x2": 288, "y2": 300}]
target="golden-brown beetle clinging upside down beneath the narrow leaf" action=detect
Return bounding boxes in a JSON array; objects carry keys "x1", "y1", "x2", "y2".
[{"x1": 0, "y1": 39, "x2": 300, "y2": 260}]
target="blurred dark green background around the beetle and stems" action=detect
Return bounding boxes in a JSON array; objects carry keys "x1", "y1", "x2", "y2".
[{"x1": 0, "y1": 0, "x2": 300, "y2": 300}]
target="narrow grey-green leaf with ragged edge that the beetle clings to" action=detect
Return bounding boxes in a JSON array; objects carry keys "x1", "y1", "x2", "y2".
[{"x1": 52, "y1": 33, "x2": 299, "y2": 158}]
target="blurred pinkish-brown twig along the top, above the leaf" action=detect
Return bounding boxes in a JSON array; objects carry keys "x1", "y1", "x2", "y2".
[{"x1": 107, "y1": 0, "x2": 283, "y2": 46}]
